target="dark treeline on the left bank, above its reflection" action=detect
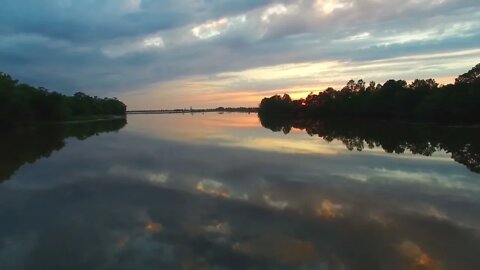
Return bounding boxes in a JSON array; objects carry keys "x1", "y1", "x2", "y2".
[{"x1": 0, "y1": 72, "x2": 127, "y2": 128}]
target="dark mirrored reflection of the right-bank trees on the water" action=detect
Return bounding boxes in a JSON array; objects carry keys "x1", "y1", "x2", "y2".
[{"x1": 259, "y1": 114, "x2": 480, "y2": 173}]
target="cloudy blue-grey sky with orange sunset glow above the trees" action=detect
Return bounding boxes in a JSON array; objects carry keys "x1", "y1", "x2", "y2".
[{"x1": 0, "y1": 0, "x2": 480, "y2": 110}]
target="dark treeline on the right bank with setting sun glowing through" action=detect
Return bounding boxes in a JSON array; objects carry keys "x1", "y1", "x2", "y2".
[{"x1": 259, "y1": 64, "x2": 480, "y2": 123}]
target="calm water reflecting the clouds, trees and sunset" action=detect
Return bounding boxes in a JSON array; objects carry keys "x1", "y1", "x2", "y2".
[{"x1": 0, "y1": 114, "x2": 480, "y2": 270}]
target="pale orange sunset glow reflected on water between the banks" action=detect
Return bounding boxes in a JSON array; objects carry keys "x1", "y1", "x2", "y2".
[{"x1": 126, "y1": 113, "x2": 378, "y2": 155}]
